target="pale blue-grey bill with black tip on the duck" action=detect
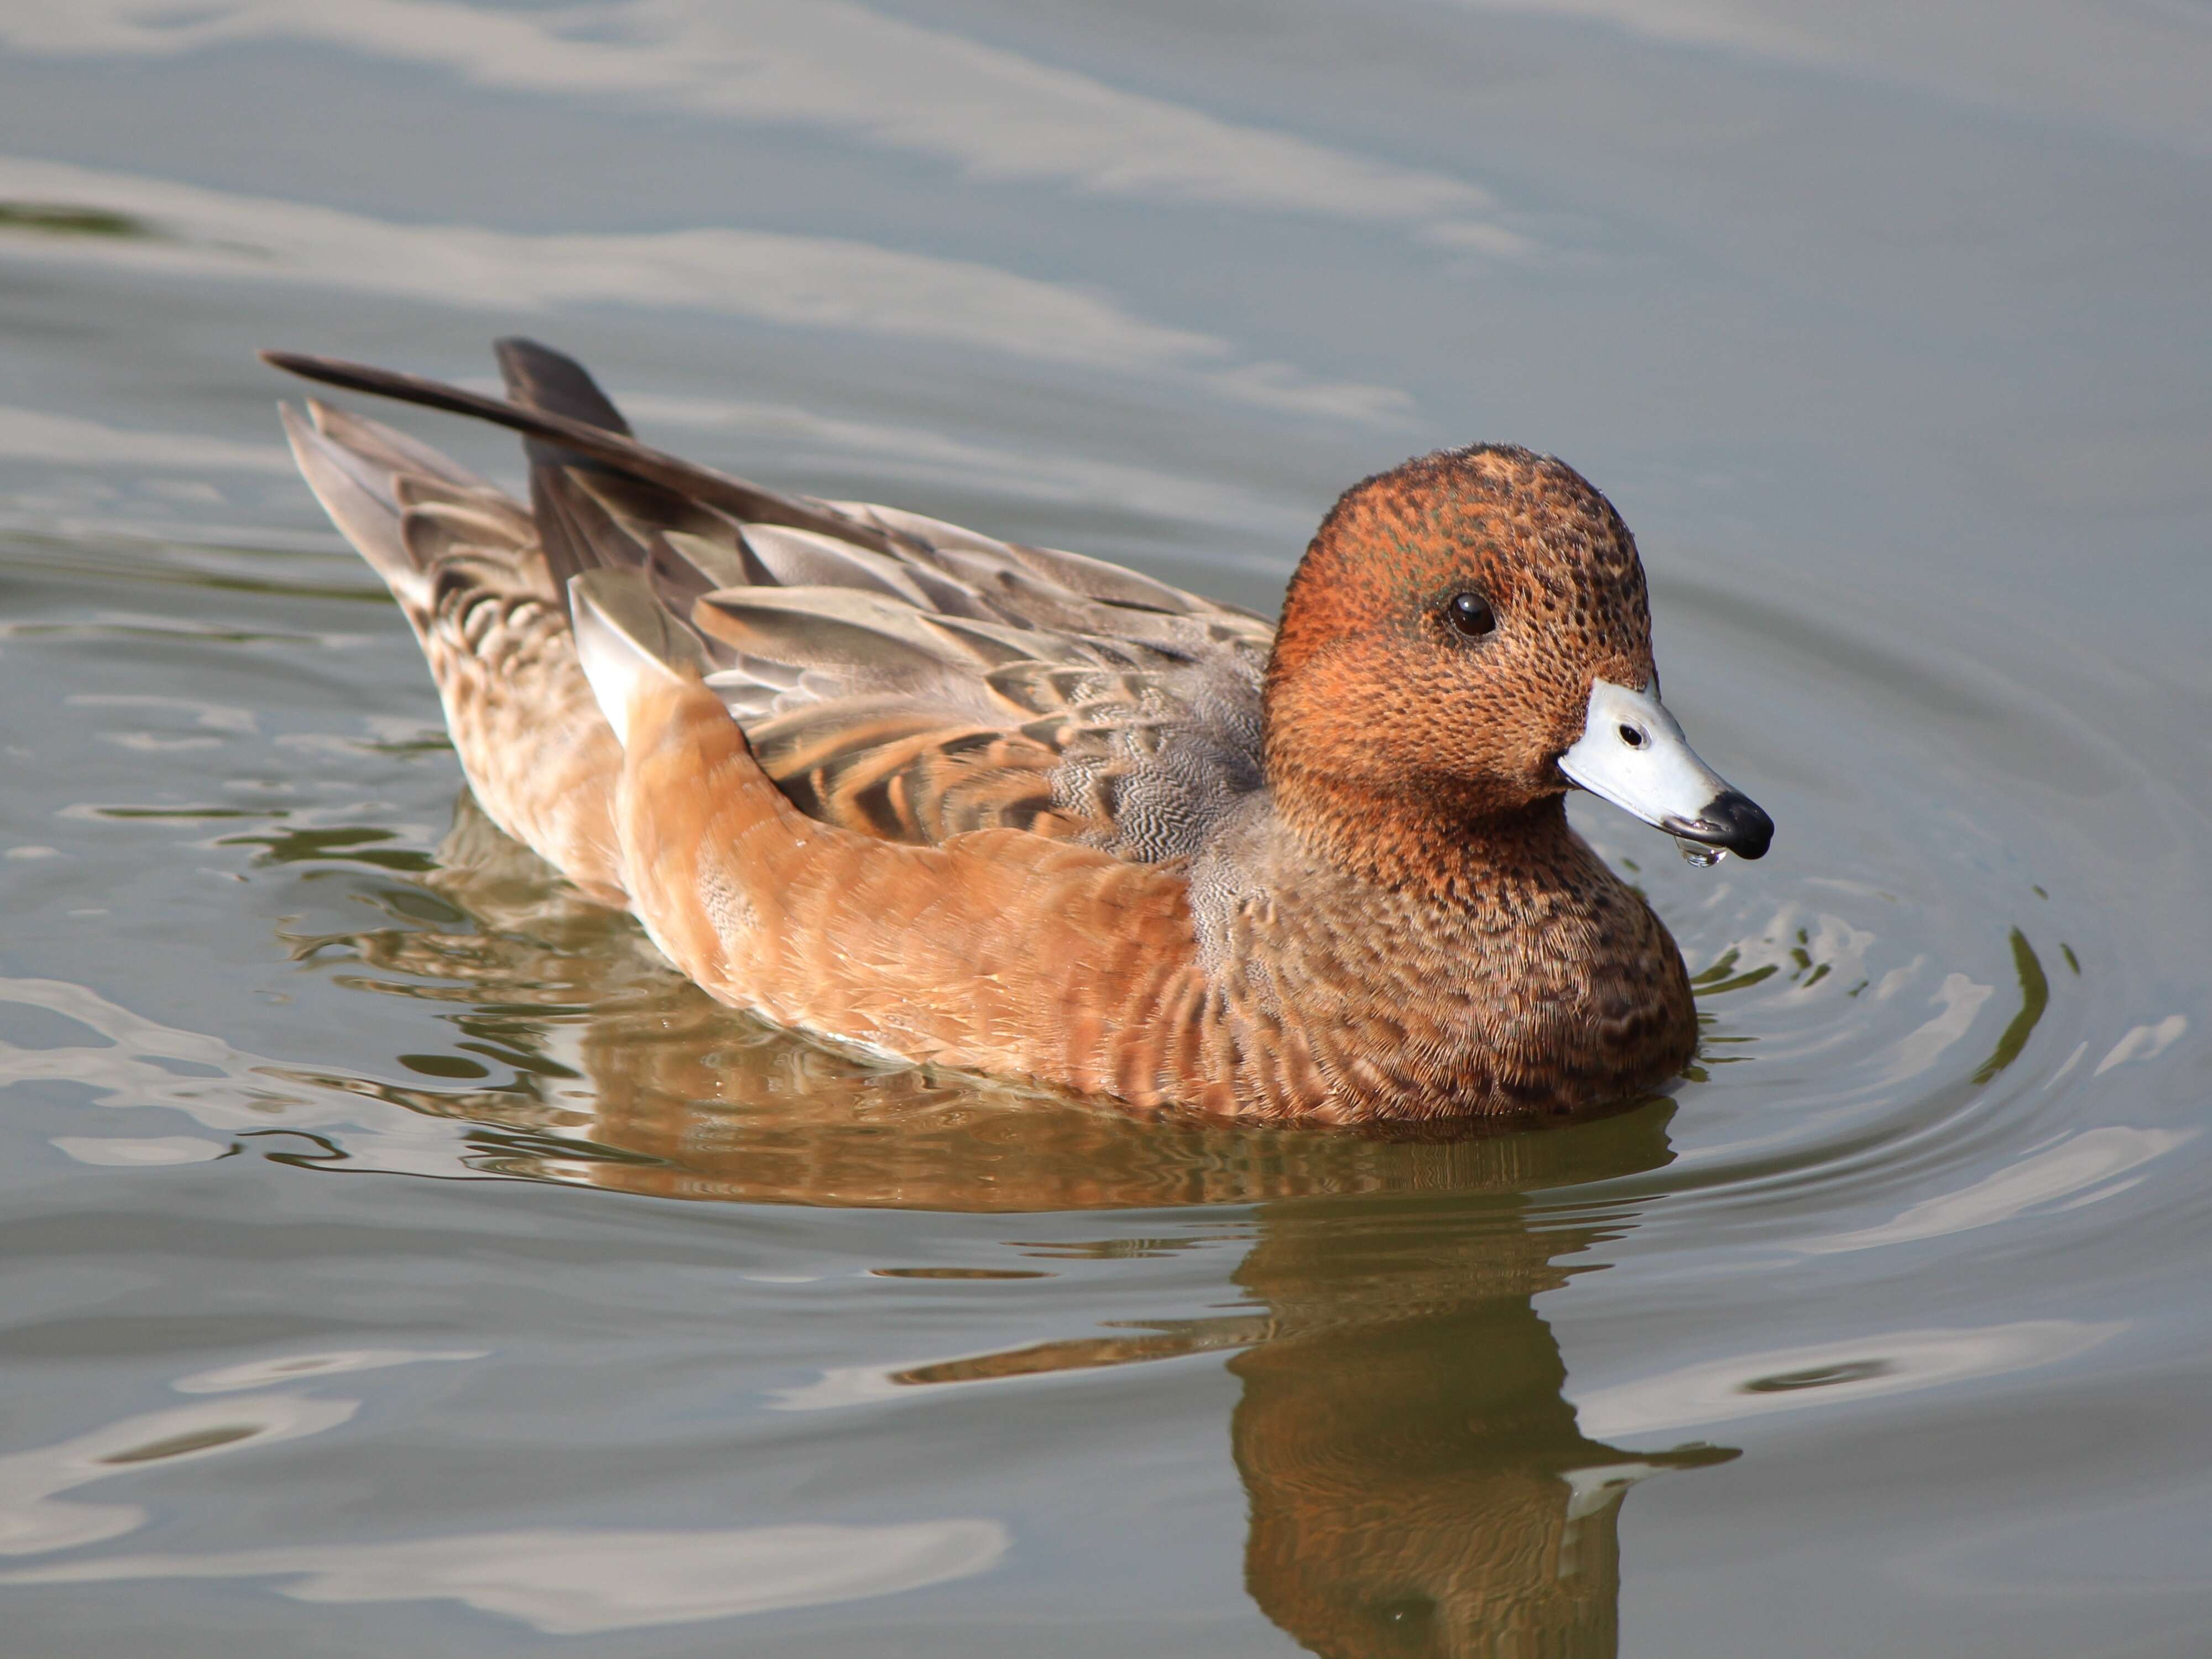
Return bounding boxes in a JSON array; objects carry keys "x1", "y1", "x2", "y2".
[{"x1": 1559, "y1": 679, "x2": 1774, "y2": 858}]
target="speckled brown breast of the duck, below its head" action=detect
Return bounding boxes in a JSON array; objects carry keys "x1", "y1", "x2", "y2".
[{"x1": 1221, "y1": 774, "x2": 1697, "y2": 1117}]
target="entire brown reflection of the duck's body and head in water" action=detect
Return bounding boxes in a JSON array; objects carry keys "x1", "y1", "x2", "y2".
[{"x1": 303, "y1": 801, "x2": 1736, "y2": 1659}]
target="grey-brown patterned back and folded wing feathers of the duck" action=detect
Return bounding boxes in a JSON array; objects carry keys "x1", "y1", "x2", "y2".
[{"x1": 562, "y1": 467, "x2": 1274, "y2": 863}]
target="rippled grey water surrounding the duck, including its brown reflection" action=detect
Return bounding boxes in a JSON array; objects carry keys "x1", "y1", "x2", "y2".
[{"x1": 0, "y1": 0, "x2": 2212, "y2": 1659}]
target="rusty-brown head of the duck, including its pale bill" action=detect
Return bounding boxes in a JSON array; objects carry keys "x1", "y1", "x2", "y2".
[{"x1": 1265, "y1": 445, "x2": 1774, "y2": 876}]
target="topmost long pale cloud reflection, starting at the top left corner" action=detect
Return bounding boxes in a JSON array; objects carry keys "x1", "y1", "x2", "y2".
[{"x1": 0, "y1": 0, "x2": 1526, "y2": 254}]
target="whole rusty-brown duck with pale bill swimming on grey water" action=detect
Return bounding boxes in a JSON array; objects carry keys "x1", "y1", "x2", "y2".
[{"x1": 261, "y1": 338, "x2": 1774, "y2": 1128}]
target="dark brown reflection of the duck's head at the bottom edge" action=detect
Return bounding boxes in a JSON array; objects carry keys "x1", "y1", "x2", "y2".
[{"x1": 1230, "y1": 1186, "x2": 1734, "y2": 1659}]
